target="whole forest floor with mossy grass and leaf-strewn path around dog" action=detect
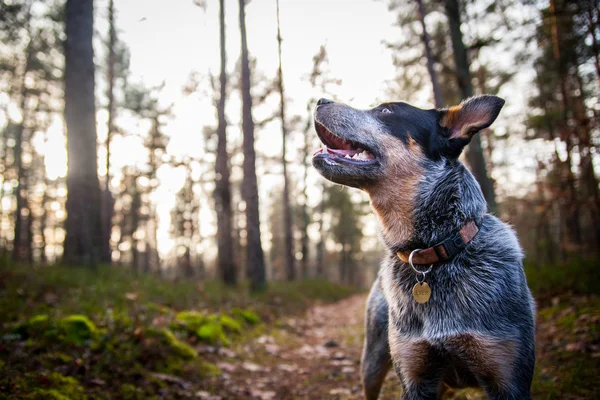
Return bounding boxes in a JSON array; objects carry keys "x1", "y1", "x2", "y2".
[{"x1": 0, "y1": 260, "x2": 600, "y2": 400}]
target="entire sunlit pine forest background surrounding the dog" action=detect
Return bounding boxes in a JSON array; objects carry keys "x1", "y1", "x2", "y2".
[{"x1": 0, "y1": 0, "x2": 600, "y2": 400}]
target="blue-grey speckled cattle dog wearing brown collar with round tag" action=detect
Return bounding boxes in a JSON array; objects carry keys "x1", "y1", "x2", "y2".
[{"x1": 312, "y1": 95, "x2": 535, "y2": 400}]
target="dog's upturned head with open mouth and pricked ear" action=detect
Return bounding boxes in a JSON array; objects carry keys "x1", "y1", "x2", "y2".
[{"x1": 313, "y1": 96, "x2": 504, "y2": 191}]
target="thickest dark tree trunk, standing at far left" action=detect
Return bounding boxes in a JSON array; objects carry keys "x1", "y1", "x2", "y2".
[{"x1": 64, "y1": 0, "x2": 102, "y2": 265}]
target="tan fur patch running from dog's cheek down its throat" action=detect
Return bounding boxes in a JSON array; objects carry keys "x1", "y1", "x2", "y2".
[{"x1": 365, "y1": 136, "x2": 425, "y2": 241}]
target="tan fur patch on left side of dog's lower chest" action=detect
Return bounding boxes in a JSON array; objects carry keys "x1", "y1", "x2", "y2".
[{"x1": 390, "y1": 335, "x2": 431, "y2": 384}]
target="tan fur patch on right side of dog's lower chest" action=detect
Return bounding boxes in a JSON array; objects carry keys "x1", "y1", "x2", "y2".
[{"x1": 447, "y1": 334, "x2": 517, "y2": 387}]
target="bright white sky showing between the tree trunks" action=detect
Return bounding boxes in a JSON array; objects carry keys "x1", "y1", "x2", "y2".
[{"x1": 97, "y1": 0, "x2": 397, "y2": 252}]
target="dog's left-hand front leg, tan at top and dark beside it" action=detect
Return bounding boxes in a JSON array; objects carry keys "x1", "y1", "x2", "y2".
[{"x1": 389, "y1": 332, "x2": 443, "y2": 400}]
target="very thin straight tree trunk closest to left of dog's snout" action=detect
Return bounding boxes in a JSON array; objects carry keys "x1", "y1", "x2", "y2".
[{"x1": 276, "y1": 0, "x2": 296, "y2": 281}]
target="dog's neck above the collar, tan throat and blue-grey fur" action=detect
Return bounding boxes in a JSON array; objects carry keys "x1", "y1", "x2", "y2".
[{"x1": 369, "y1": 161, "x2": 487, "y2": 252}]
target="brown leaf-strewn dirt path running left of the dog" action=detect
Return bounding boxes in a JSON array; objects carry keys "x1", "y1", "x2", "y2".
[{"x1": 197, "y1": 295, "x2": 400, "y2": 400}]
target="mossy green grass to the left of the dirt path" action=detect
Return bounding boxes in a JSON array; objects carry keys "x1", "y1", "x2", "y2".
[{"x1": 0, "y1": 263, "x2": 356, "y2": 400}]
